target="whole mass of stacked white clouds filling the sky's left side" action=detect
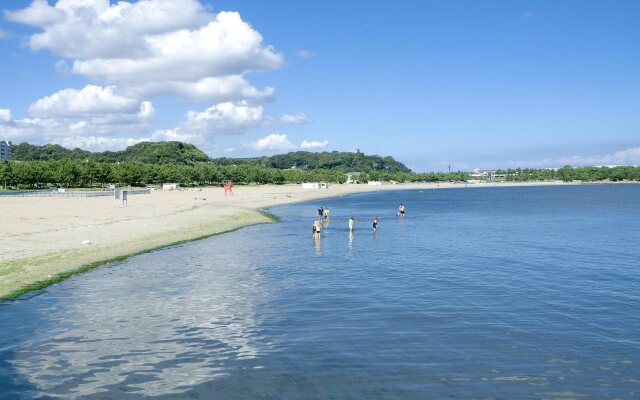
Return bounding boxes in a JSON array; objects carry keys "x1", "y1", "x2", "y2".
[{"x1": 0, "y1": 0, "x2": 308, "y2": 152}]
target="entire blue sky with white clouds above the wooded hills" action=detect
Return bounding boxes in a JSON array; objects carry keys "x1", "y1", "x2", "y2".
[{"x1": 0, "y1": 0, "x2": 640, "y2": 171}]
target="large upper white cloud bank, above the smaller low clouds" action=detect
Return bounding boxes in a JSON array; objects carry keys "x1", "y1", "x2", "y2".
[{"x1": 5, "y1": 0, "x2": 283, "y2": 102}]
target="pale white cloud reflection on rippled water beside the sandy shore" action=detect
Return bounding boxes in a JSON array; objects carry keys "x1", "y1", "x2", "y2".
[{"x1": 3, "y1": 238, "x2": 269, "y2": 398}]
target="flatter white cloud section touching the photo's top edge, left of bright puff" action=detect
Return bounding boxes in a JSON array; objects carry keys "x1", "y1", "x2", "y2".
[{"x1": 5, "y1": 0, "x2": 211, "y2": 59}]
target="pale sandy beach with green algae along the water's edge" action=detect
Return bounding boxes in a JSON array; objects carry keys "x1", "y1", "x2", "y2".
[{"x1": 0, "y1": 182, "x2": 637, "y2": 301}]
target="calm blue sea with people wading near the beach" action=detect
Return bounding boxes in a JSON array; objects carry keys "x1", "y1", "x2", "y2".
[{"x1": 0, "y1": 185, "x2": 640, "y2": 399}]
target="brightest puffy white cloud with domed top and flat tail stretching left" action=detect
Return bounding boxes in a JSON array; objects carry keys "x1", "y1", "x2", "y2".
[{"x1": 73, "y1": 12, "x2": 282, "y2": 83}]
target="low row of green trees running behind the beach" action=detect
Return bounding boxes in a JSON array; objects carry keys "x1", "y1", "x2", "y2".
[{"x1": 0, "y1": 159, "x2": 640, "y2": 189}]
